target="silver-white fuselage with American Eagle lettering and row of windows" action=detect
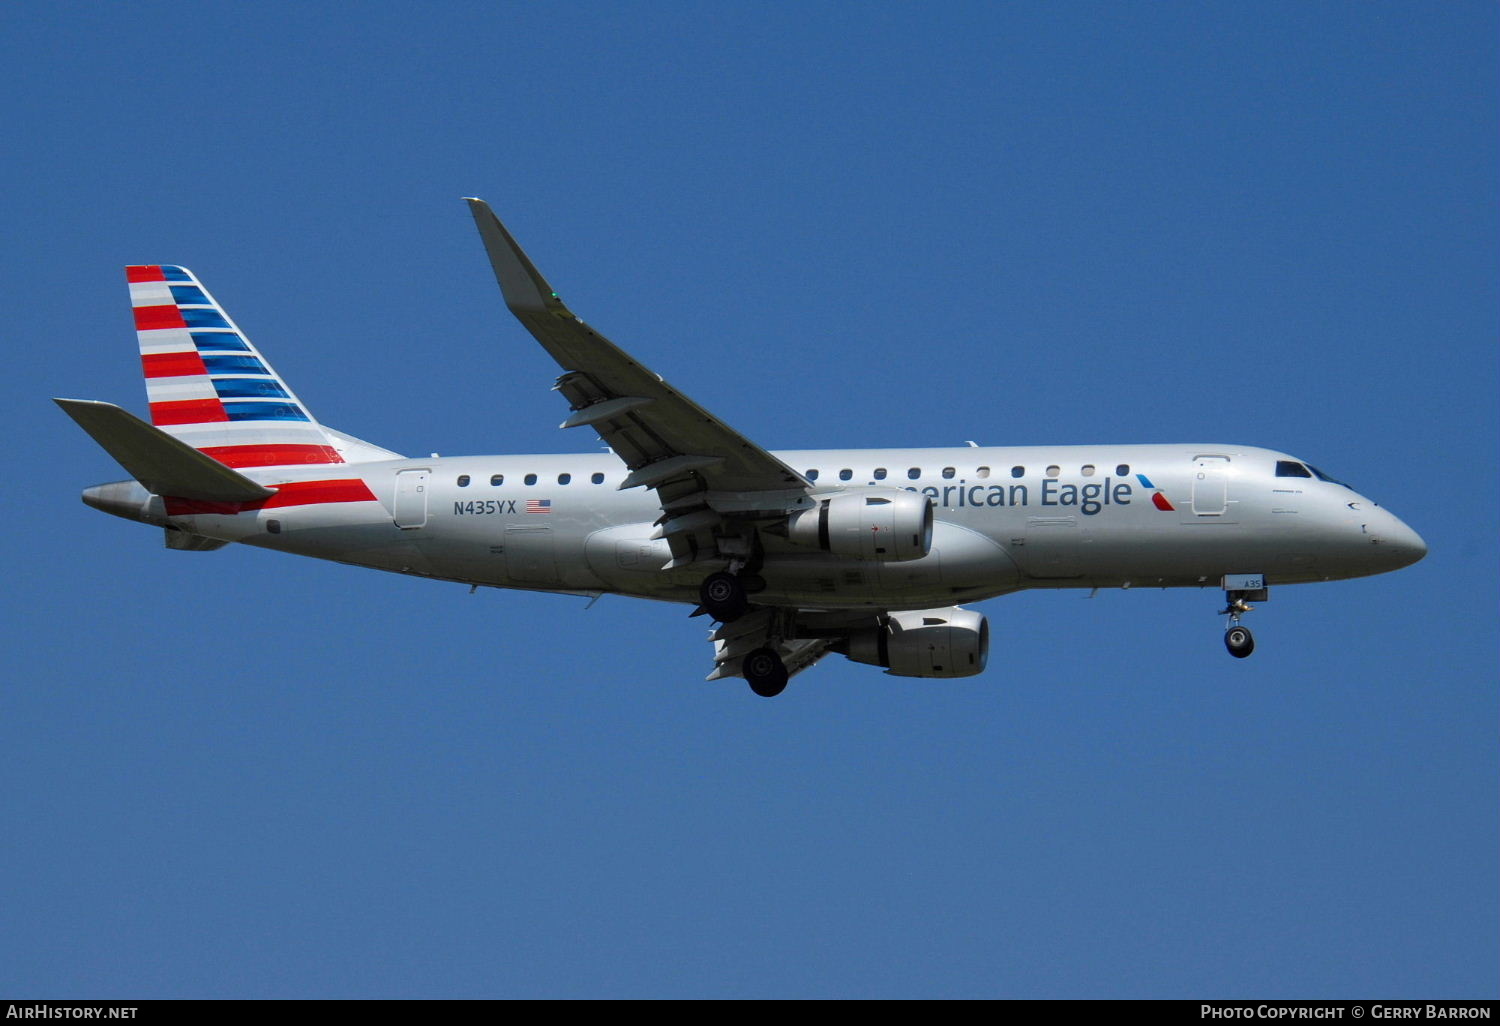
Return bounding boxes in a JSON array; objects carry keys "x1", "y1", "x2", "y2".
[{"x1": 86, "y1": 444, "x2": 1427, "y2": 609}]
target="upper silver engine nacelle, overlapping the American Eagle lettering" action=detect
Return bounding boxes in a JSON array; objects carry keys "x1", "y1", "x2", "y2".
[{"x1": 786, "y1": 488, "x2": 933, "y2": 563}]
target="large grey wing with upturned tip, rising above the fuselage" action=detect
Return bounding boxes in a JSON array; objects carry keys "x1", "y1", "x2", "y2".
[{"x1": 468, "y1": 200, "x2": 812, "y2": 566}]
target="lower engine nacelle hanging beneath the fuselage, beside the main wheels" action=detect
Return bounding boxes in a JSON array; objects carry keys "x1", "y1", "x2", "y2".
[{"x1": 834, "y1": 606, "x2": 990, "y2": 677}]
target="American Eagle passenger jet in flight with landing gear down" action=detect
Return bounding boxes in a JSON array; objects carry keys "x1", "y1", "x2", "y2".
[{"x1": 54, "y1": 198, "x2": 1427, "y2": 698}]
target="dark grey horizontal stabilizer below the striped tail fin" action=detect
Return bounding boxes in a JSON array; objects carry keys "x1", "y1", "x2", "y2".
[{"x1": 53, "y1": 399, "x2": 276, "y2": 503}]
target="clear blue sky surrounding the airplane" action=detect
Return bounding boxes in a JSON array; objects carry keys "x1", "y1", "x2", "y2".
[{"x1": 0, "y1": 3, "x2": 1500, "y2": 998}]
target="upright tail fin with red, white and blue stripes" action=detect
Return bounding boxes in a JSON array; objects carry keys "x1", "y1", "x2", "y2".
[{"x1": 126, "y1": 264, "x2": 399, "y2": 468}]
